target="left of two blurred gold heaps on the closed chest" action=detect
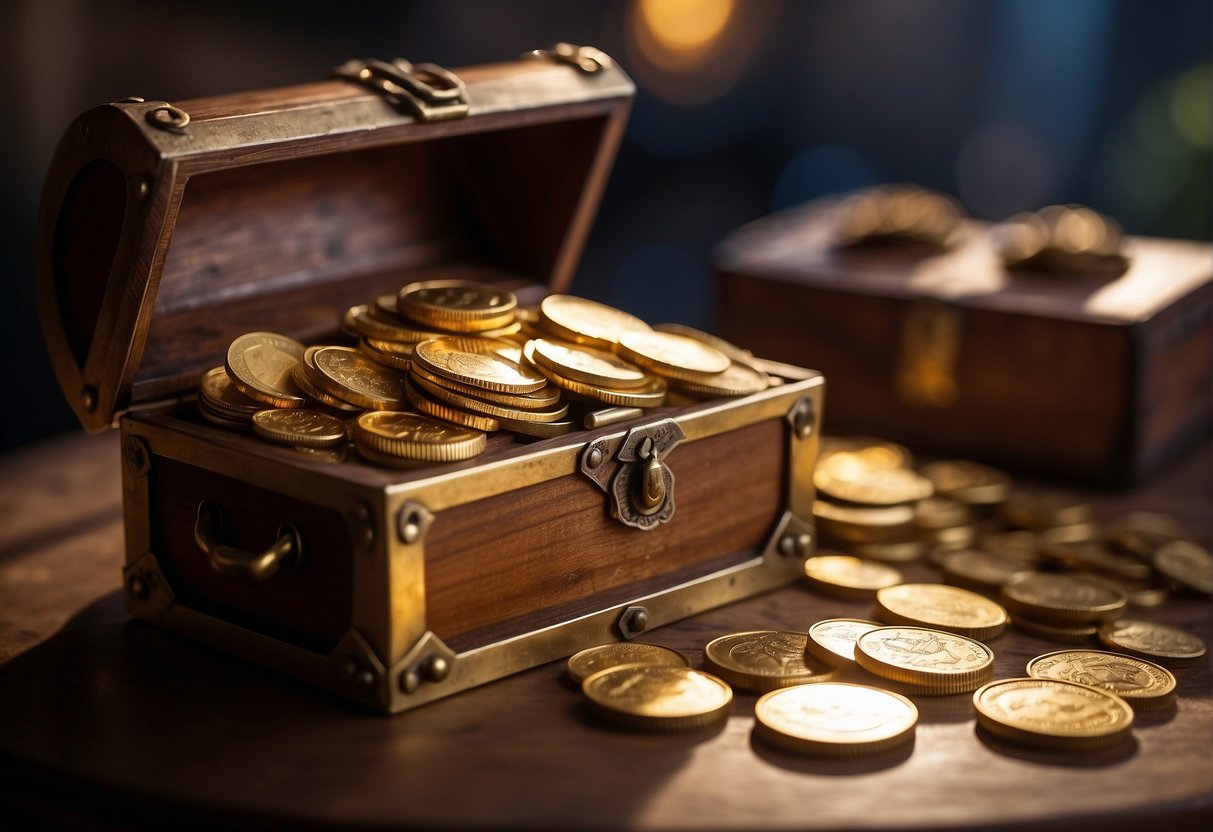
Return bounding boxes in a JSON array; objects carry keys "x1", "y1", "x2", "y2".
[{"x1": 837, "y1": 184, "x2": 966, "y2": 249}]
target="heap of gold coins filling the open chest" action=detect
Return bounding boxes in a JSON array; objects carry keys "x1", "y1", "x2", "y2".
[{"x1": 198, "y1": 280, "x2": 779, "y2": 467}]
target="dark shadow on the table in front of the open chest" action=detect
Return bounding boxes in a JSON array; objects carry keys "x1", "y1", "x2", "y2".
[{"x1": 0, "y1": 592, "x2": 714, "y2": 828}]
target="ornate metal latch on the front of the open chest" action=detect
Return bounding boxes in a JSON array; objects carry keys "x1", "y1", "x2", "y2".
[{"x1": 581, "y1": 418, "x2": 687, "y2": 531}]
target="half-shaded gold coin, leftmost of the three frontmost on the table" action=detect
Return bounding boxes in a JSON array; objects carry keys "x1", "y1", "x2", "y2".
[{"x1": 581, "y1": 665, "x2": 733, "y2": 731}]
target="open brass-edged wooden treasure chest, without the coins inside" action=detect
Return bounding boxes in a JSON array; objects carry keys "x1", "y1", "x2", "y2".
[{"x1": 36, "y1": 45, "x2": 824, "y2": 712}]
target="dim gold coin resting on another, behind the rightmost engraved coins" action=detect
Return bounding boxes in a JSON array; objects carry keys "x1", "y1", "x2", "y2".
[{"x1": 1002, "y1": 571, "x2": 1128, "y2": 626}]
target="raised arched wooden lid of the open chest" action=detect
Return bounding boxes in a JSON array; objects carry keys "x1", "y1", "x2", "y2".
[{"x1": 36, "y1": 45, "x2": 634, "y2": 431}]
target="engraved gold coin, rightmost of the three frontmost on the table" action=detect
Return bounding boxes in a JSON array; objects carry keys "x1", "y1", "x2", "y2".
[{"x1": 973, "y1": 678, "x2": 1133, "y2": 751}]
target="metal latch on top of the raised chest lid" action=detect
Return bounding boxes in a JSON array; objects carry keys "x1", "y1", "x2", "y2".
[{"x1": 330, "y1": 58, "x2": 467, "y2": 121}]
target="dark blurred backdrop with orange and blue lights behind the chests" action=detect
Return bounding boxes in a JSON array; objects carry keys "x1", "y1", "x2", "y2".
[{"x1": 0, "y1": 0, "x2": 1213, "y2": 451}]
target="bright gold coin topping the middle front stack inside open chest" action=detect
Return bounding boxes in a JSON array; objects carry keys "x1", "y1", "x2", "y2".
[{"x1": 412, "y1": 337, "x2": 547, "y2": 393}]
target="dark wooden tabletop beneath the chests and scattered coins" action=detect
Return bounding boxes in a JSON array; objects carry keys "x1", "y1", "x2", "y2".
[{"x1": 0, "y1": 435, "x2": 1213, "y2": 830}]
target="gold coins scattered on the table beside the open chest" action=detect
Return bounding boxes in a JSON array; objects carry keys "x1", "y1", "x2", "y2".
[{"x1": 568, "y1": 438, "x2": 1213, "y2": 757}]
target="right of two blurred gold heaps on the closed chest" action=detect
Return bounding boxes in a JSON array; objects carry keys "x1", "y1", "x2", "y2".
[{"x1": 993, "y1": 205, "x2": 1128, "y2": 277}]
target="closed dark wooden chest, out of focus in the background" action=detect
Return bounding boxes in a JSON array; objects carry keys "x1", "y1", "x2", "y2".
[{"x1": 716, "y1": 199, "x2": 1213, "y2": 485}]
